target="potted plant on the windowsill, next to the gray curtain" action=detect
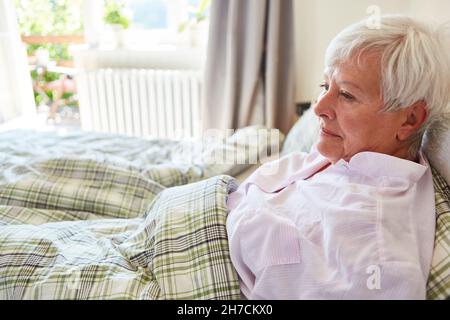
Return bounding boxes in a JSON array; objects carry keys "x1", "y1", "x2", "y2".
[{"x1": 178, "y1": 0, "x2": 211, "y2": 47}]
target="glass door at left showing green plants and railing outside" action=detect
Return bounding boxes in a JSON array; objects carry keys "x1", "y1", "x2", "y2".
[{"x1": 14, "y1": 0, "x2": 84, "y2": 125}]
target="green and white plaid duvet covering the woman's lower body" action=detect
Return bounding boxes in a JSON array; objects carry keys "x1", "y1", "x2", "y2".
[{"x1": 0, "y1": 158, "x2": 240, "y2": 299}]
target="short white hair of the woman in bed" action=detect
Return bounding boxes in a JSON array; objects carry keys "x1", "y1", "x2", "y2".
[{"x1": 325, "y1": 15, "x2": 450, "y2": 156}]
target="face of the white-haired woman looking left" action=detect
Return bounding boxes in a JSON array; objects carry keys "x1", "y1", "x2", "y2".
[{"x1": 314, "y1": 54, "x2": 404, "y2": 163}]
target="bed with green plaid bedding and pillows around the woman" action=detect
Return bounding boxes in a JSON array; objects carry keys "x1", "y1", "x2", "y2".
[{"x1": 0, "y1": 113, "x2": 450, "y2": 299}]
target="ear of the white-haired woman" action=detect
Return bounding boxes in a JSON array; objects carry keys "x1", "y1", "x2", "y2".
[{"x1": 397, "y1": 100, "x2": 428, "y2": 141}]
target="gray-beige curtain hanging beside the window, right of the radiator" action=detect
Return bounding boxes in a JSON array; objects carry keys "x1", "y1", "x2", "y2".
[{"x1": 202, "y1": 0, "x2": 295, "y2": 133}]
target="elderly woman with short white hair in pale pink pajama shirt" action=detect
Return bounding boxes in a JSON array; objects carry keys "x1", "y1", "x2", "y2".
[{"x1": 227, "y1": 16, "x2": 450, "y2": 299}]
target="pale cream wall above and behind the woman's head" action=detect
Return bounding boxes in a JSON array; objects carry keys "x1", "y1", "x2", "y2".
[{"x1": 294, "y1": 0, "x2": 450, "y2": 102}]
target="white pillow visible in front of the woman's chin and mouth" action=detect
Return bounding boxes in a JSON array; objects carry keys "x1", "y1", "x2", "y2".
[{"x1": 281, "y1": 107, "x2": 319, "y2": 156}]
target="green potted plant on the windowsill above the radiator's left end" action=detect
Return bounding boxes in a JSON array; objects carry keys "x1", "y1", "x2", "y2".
[{"x1": 103, "y1": 0, "x2": 131, "y2": 47}]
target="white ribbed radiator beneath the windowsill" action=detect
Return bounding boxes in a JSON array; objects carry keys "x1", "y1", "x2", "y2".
[{"x1": 77, "y1": 69, "x2": 202, "y2": 139}]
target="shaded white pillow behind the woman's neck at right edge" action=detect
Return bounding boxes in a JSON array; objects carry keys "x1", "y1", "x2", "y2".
[{"x1": 422, "y1": 114, "x2": 450, "y2": 185}]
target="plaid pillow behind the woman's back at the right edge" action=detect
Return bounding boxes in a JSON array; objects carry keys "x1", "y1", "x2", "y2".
[{"x1": 427, "y1": 167, "x2": 450, "y2": 300}]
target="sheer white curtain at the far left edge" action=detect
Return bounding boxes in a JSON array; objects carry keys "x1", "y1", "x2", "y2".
[{"x1": 0, "y1": 0, "x2": 36, "y2": 123}]
